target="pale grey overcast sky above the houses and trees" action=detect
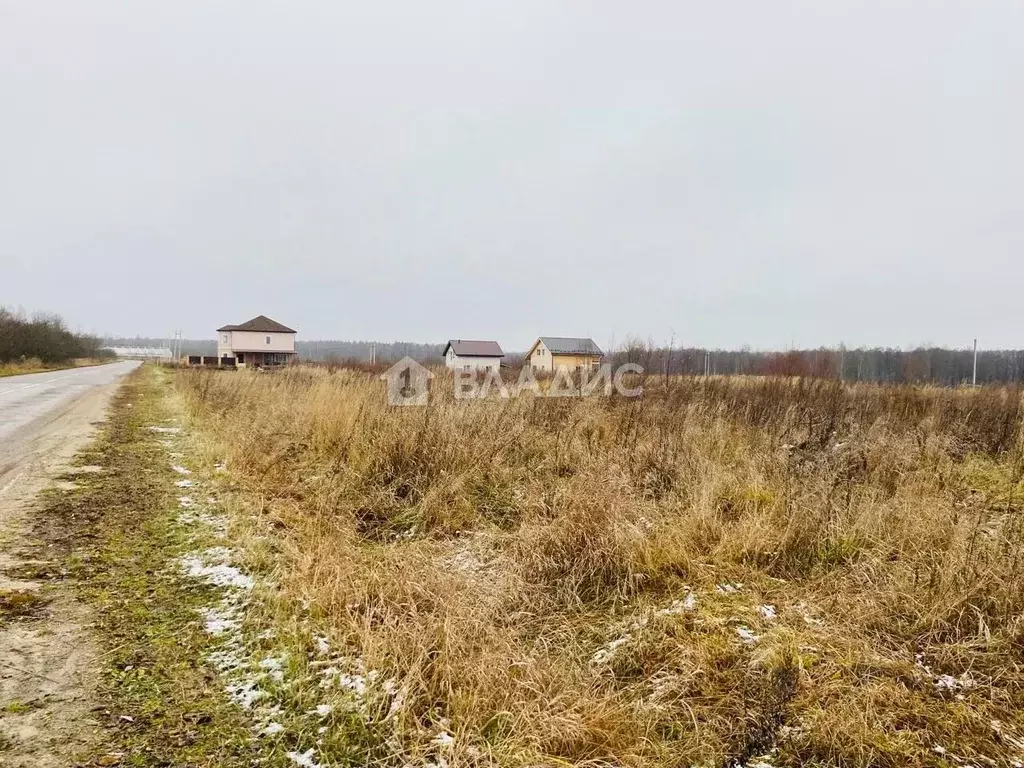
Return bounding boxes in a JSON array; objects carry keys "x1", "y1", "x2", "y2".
[{"x1": 0, "y1": 0, "x2": 1024, "y2": 349}]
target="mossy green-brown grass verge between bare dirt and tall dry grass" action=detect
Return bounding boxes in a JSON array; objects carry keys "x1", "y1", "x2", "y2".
[{"x1": 16, "y1": 367, "x2": 258, "y2": 768}]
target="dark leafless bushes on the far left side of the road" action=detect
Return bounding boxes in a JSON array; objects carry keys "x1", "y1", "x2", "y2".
[{"x1": 0, "y1": 307, "x2": 111, "y2": 362}]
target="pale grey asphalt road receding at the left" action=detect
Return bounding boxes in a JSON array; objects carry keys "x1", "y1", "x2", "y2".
[{"x1": 0, "y1": 360, "x2": 139, "y2": 444}]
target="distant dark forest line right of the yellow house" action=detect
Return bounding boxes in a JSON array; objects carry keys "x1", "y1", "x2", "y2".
[{"x1": 610, "y1": 342, "x2": 1024, "y2": 386}]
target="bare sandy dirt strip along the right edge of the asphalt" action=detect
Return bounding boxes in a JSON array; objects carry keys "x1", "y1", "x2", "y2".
[{"x1": 0, "y1": 382, "x2": 118, "y2": 768}]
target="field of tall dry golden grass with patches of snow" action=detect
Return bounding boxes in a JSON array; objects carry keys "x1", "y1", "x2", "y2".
[{"x1": 176, "y1": 368, "x2": 1024, "y2": 768}]
